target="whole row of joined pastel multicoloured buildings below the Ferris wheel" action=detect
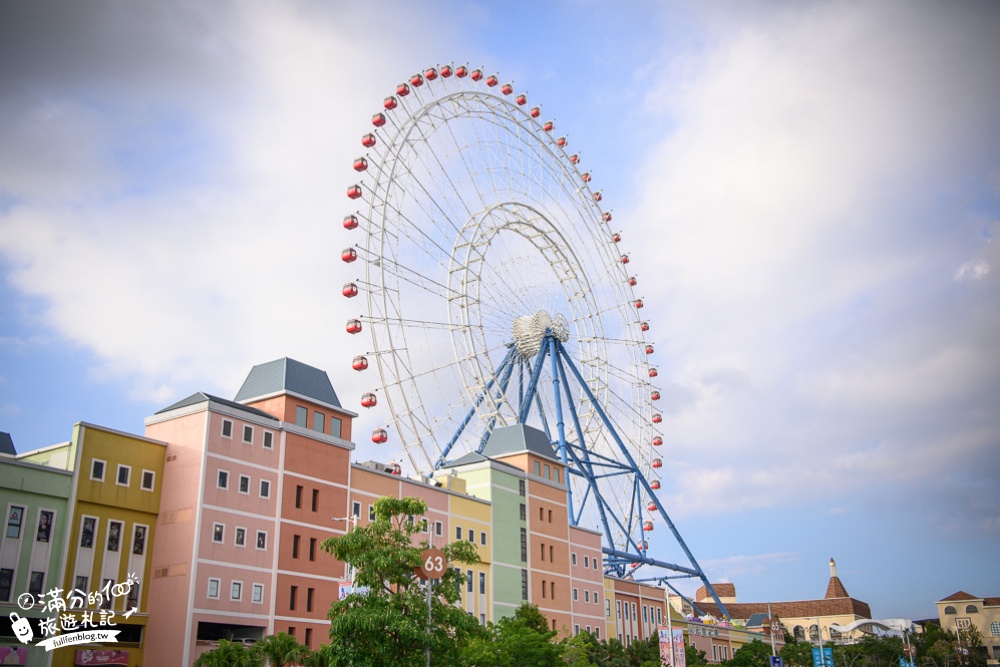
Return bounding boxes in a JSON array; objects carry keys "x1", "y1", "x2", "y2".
[{"x1": 0, "y1": 358, "x2": 796, "y2": 667}]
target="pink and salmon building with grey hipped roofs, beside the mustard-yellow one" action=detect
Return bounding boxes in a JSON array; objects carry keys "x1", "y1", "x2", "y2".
[{"x1": 146, "y1": 358, "x2": 357, "y2": 665}]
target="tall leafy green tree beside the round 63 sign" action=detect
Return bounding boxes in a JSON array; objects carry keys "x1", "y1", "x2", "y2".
[{"x1": 323, "y1": 497, "x2": 482, "y2": 667}]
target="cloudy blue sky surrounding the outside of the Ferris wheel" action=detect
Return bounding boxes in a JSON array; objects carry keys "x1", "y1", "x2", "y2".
[{"x1": 0, "y1": 0, "x2": 1000, "y2": 618}]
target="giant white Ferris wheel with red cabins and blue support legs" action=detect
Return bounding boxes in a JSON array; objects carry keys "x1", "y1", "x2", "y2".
[{"x1": 342, "y1": 65, "x2": 721, "y2": 606}]
